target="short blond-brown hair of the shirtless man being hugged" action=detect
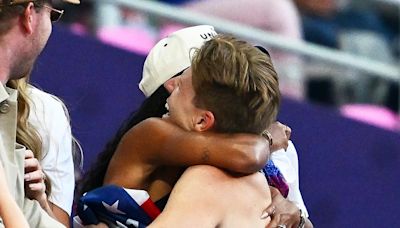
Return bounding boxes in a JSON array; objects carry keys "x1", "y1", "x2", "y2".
[{"x1": 192, "y1": 35, "x2": 280, "y2": 134}]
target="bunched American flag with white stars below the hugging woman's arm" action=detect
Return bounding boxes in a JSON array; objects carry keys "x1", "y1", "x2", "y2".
[{"x1": 77, "y1": 185, "x2": 160, "y2": 228}]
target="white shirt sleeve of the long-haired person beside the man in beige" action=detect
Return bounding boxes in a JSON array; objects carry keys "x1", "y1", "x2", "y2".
[{"x1": 28, "y1": 87, "x2": 75, "y2": 215}]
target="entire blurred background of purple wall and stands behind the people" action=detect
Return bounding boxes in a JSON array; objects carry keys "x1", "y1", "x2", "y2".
[{"x1": 32, "y1": 0, "x2": 400, "y2": 227}]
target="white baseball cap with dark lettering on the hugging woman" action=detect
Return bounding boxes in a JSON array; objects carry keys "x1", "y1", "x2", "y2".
[{"x1": 139, "y1": 25, "x2": 217, "y2": 97}]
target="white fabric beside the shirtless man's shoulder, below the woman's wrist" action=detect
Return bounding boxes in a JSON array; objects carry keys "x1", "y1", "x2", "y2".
[{"x1": 271, "y1": 141, "x2": 308, "y2": 217}]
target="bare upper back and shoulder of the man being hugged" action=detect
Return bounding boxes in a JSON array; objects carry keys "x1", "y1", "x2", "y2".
[{"x1": 167, "y1": 165, "x2": 271, "y2": 227}]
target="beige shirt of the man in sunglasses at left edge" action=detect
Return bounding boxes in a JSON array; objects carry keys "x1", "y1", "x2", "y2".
[{"x1": 0, "y1": 83, "x2": 64, "y2": 228}]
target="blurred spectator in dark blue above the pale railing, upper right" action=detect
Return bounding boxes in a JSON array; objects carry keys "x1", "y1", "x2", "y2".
[{"x1": 295, "y1": 0, "x2": 393, "y2": 48}]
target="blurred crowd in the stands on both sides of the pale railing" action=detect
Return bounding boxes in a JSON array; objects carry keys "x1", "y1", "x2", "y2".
[{"x1": 54, "y1": 0, "x2": 400, "y2": 112}]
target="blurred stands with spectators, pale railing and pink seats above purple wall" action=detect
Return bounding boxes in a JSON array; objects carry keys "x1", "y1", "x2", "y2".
[{"x1": 54, "y1": 0, "x2": 400, "y2": 118}]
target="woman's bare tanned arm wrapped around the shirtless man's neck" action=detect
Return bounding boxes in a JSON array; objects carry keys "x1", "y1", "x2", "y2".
[{"x1": 117, "y1": 118, "x2": 270, "y2": 174}]
